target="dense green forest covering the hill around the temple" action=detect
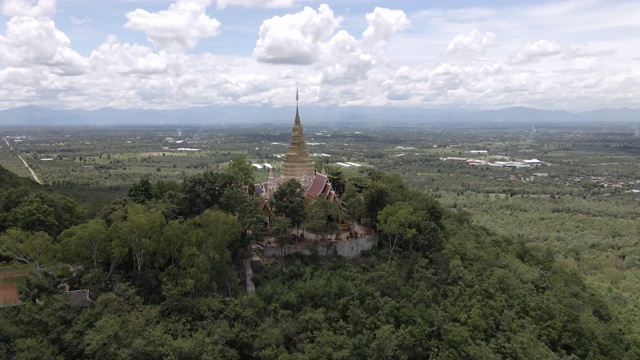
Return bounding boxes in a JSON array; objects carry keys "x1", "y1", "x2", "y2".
[{"x1": 0, "y1": 161, "x2": 640, "y2": 359}]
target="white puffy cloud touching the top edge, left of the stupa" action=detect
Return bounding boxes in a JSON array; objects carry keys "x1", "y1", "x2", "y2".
[{"x1": 124, "y1": 0, "x2": 220, "y2": 50}]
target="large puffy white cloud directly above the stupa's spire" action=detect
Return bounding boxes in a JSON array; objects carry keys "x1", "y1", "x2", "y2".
[{"x1": 253, "y1": 4, "x2": 342, "y2": 65}]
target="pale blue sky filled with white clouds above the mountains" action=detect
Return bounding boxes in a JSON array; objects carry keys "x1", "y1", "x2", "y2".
[{"x1": 0, "y1": 0, "x2": 640, "y2": 112}]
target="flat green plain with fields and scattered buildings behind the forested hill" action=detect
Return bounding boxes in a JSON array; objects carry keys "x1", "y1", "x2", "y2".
[{"x1": 5, "y1": 125, "x2": 640, "y2": 280}]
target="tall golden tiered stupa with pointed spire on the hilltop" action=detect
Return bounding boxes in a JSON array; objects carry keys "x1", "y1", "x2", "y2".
[{"x1": 278, "y1": 88, "x2": 316, "y2": 188}]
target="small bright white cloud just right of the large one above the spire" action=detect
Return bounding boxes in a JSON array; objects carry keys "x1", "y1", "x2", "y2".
[{"x1": 362, "y1": 7, "x2": 411, "y2": 50}]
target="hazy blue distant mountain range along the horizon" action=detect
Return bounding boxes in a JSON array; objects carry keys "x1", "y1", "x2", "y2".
[{"x1": 0, "y1": 105, "x2": 640, "y2": 127}]
